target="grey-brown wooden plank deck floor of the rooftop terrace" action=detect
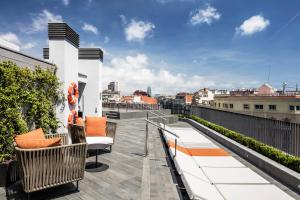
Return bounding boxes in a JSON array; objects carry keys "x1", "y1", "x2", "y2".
[{"x1": 0, "y1": 119, "x2": 179, "y2": 200}]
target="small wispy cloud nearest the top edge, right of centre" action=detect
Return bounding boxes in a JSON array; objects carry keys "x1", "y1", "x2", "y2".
[{"x1": 190, "y1": 4, "x2": 221, "y2": 25}]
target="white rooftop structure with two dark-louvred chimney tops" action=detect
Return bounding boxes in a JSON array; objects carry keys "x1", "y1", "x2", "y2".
[{"x1": 43, "y1": 23, "x2": 103, "y2": 132}]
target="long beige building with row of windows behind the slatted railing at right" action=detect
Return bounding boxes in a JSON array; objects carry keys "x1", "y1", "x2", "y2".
[{"x1": 212, "y1": 95, "x2": 300, "y2": 123}]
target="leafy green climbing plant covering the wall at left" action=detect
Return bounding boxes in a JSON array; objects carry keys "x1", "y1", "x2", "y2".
[{"x1": 0, "y1": 62, "x2": 64, "y2": 162}]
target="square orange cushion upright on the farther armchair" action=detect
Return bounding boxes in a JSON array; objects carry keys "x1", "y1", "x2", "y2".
[{"x1": 85, "y1": 116, "x2": 106, "y2": 136}]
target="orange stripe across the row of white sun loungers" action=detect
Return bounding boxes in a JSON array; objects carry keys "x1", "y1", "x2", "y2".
[{"x1": 167, "y1": 141, "x2": 229, "y2": 156}]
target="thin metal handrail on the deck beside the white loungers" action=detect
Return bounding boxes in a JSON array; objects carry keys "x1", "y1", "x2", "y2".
[{"x1": 144, "y1": 111, "x2": 179, "y2": 157}]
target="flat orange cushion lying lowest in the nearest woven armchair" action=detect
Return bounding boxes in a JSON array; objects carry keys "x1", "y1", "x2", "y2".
[{"x1": 15, "y1": 138, "x2": 61, "y2": 149}]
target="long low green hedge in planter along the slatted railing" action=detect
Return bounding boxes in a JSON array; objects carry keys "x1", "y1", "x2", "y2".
[{"x1": 179, "y1": 115, "x2": 300, "y2": 172}]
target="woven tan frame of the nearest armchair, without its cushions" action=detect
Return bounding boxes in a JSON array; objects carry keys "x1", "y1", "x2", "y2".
[{"x1": 15, "y1": 134, "x2": 87, "y2": 194}]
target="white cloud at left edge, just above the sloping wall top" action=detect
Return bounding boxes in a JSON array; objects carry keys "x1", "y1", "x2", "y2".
[{"x1": 0, "y1": 32, "x2": 36, "y2": 51}]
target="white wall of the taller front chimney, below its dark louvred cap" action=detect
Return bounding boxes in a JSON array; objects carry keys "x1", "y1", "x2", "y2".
[{"x1": 49, "y1": 40, "x2": 78, "y2": 133}]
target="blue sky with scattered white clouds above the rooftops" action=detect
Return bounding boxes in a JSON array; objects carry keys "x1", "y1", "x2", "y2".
[{"x1": 0, "y1": 0, "x2": 300, "y2": 94}]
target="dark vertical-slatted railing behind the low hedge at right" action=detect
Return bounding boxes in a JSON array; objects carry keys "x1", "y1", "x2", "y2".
[{"x1": 189, "y1": 106, "x2": 300, "y2": 157}]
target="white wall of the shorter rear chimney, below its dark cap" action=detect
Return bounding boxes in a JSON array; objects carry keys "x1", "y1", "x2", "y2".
[{"x1": 78, "y1": 59, "x2": 102, "y2": 116}]
